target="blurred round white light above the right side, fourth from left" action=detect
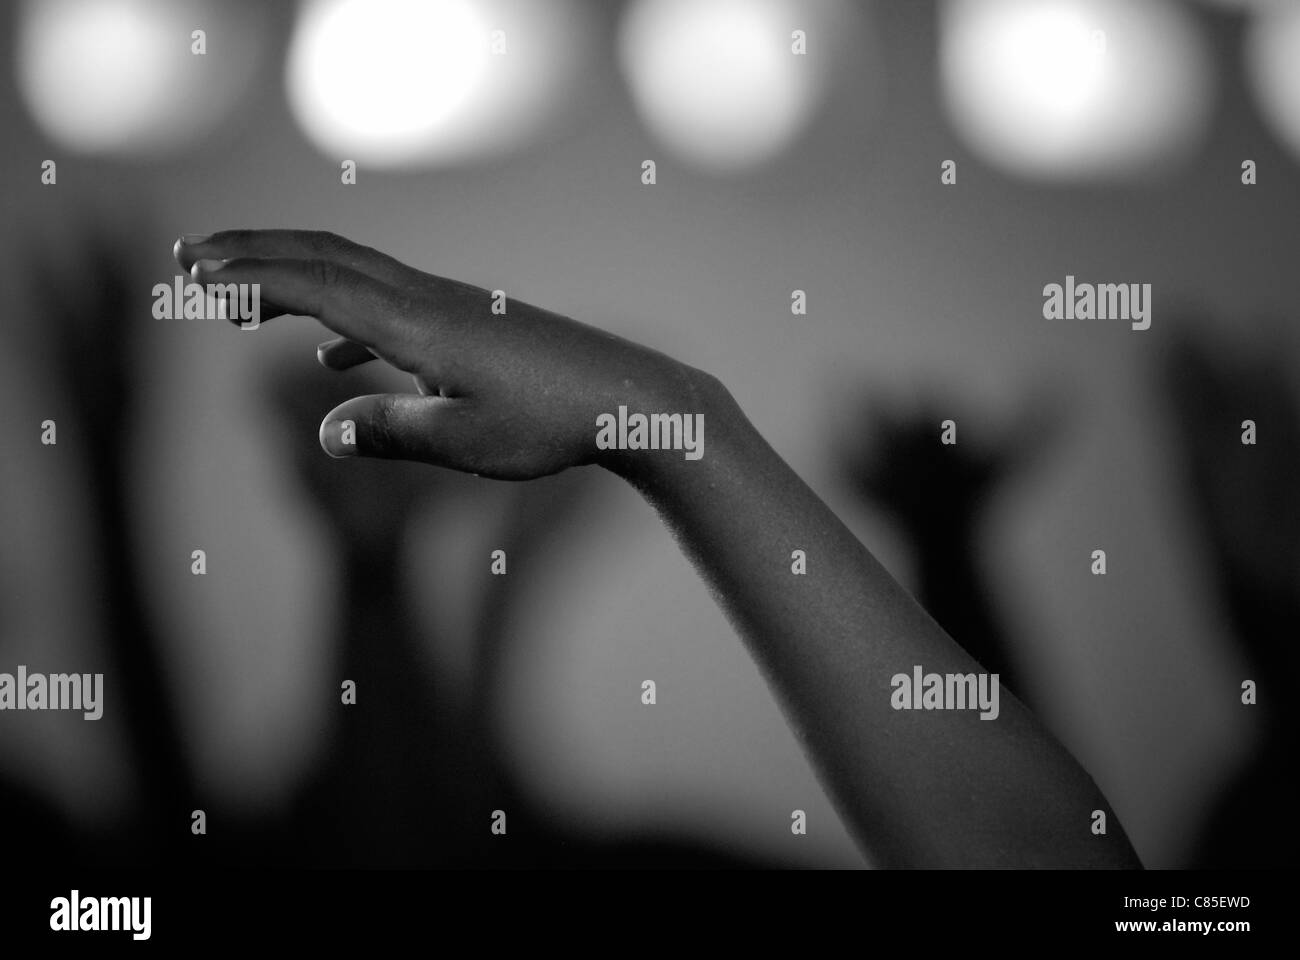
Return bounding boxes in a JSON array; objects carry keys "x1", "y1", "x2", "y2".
[{"x1": 939, "y1": 0, "x2": 1212, "y2": 180}]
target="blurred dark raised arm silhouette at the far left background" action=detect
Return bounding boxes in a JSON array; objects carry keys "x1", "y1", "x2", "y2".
[{"x1": 14, "y1": 224, "x2": 196, "y2": 862}]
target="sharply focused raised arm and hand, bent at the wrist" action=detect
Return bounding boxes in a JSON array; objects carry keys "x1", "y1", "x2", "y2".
[{"x1": 176, "y1": 230, "x2": 1140, "y2": 868}]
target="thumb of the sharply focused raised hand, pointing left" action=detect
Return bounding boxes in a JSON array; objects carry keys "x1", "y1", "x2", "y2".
[{"x1": 320, "y1": 393, "x2": 468, "y2": 467}]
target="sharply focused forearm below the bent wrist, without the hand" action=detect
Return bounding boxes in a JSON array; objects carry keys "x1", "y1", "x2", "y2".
[{"x1": 619, "y1": 366, "x2": 1138, "y2": 866}]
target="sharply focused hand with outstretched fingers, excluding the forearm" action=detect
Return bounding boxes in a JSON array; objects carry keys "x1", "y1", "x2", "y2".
[{"x1": 174, "y1": 230, "x2": 711, "y2": 480}]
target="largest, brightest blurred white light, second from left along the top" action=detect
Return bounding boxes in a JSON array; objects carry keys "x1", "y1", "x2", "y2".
[{"x1": 286, "y1": 0, "x2": 585, "y2": 167}]
